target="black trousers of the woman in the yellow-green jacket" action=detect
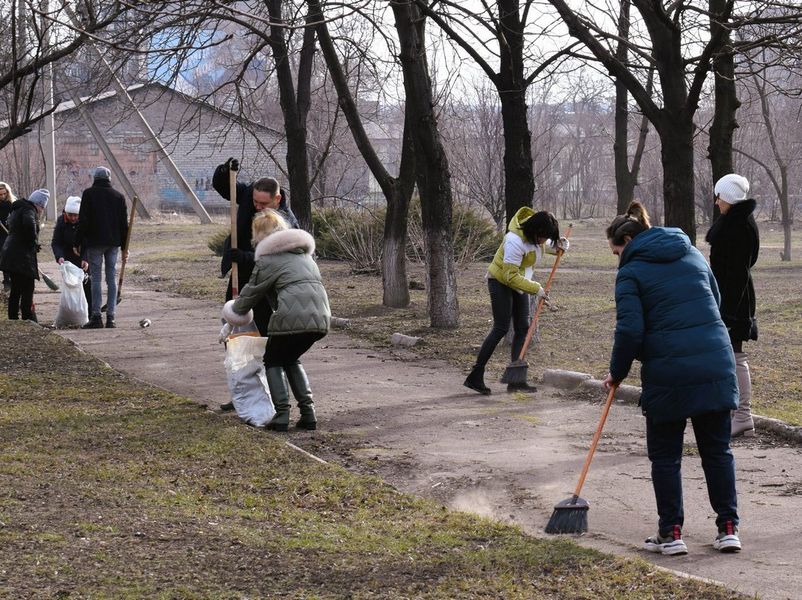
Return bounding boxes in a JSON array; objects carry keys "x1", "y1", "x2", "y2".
[{"x1": 476, "y1": 277, "x2": 529, "y2": 367}]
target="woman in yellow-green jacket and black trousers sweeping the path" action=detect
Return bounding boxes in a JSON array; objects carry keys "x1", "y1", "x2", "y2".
[{"x1": 464, "y1": 206, "x2": 568, "y2": 395}]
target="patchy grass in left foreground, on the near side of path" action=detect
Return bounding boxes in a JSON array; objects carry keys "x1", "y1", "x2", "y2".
[{"x1": 0, "y1": 322, "x2": 738, "y2": 599}]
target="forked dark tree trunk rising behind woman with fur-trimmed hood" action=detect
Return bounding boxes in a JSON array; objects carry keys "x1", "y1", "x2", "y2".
[{"x1": 266, "y1": 0, "x2": 314, "y2": 231}]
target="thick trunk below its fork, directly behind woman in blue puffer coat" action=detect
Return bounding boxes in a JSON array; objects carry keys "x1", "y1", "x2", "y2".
[{"x1": 658, "y1": 119, "x2": 696, "y2": 244}]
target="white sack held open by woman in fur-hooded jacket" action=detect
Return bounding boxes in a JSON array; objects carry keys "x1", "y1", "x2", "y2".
[{"x1": 225, "y1": 335, "x2": 276, "y2": 427}]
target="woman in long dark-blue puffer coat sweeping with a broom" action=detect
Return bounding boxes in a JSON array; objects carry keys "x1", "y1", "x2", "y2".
[{"x1": 604, "y1": 202, "x2": 741, "y2": 555}]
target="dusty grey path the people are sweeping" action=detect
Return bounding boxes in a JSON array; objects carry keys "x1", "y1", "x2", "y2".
[{"x1": 29, "y1": 287, "x2": 802, "y2": 598}]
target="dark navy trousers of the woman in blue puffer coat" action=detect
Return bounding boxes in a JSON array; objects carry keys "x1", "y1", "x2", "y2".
[{"x1": 646, "y1": 410, "x2": 738, "y2": 535}]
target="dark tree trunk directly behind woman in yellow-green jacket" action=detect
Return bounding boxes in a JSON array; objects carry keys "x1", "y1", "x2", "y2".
[{"x1": 495, "y1": 0, "x2": 535, "y2": 224}]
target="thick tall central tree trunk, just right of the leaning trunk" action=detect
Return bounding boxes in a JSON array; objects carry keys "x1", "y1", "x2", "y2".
[{"x1": 392, "y1": 0, "x2": 459, "y2": 327}]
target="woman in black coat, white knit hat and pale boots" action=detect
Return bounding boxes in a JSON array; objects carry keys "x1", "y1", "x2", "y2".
[{"x1": 706, "y1": 173, "x2": 760, "y2": 437}]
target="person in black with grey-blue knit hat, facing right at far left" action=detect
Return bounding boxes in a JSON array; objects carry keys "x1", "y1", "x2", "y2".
[{"x1": 0, "y1": 189, "x2": 50, "y2": 321}]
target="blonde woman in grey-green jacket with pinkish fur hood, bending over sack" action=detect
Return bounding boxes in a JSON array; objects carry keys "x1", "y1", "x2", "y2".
[{"x1": 223, "y1": 209, "x2": 331, "y2": 431}]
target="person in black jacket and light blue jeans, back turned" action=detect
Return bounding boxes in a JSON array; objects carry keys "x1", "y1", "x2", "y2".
[{"x1": 78, "y1": 167, "x2": 128, "y2": 329}]
